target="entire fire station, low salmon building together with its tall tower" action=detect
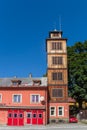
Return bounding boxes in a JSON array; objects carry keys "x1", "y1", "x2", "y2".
[{"x1": 0, "y1": 31, "x2": 69, "y2": 126}]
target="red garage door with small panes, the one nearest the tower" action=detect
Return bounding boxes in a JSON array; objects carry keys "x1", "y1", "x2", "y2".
[{"x1": 27, "y1": 110, "x2": 43, "y2": 125}]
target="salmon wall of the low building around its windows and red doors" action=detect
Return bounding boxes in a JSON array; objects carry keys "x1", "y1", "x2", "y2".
[{"x1": 0, "y1": 88, "x2": 47, "y2": 124}]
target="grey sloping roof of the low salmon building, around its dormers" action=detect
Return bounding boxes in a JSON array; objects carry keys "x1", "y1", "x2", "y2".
[{"x1": 0, "y1": 77, "x2": 47, "y2": 87}]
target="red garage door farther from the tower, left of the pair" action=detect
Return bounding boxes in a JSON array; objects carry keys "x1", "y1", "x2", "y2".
[{"x1": 7, "y1": 110, "x2": 24, "y2": 126}]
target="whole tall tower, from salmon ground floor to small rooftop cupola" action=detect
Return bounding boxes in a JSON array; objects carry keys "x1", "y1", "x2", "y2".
[{"x1": 46, "y1": 30, "x2": 69, "y2": 122}]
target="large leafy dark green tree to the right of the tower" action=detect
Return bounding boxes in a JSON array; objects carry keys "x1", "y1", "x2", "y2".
[{"x1": 67, "y1": 41, "x2": 87, "y2": 109}]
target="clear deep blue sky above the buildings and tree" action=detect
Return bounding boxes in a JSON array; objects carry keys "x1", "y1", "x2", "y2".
[{"x1": 0, "y1": 0, "x2": 87, "y2": 77}]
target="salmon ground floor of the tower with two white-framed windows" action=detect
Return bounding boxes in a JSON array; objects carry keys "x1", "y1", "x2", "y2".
[{"x1": 49, "y1": 102, "x2": 69, "y2": 123}]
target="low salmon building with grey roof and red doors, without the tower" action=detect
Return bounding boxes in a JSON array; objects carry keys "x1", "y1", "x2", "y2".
[{"x1": 0, "y1": 77, "x2": 47, "y2": 126}]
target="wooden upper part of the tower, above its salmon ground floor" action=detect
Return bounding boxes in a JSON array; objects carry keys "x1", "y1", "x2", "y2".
[{"x1": 46, "y1": 30, "x2": 68, "y2": 102}]
